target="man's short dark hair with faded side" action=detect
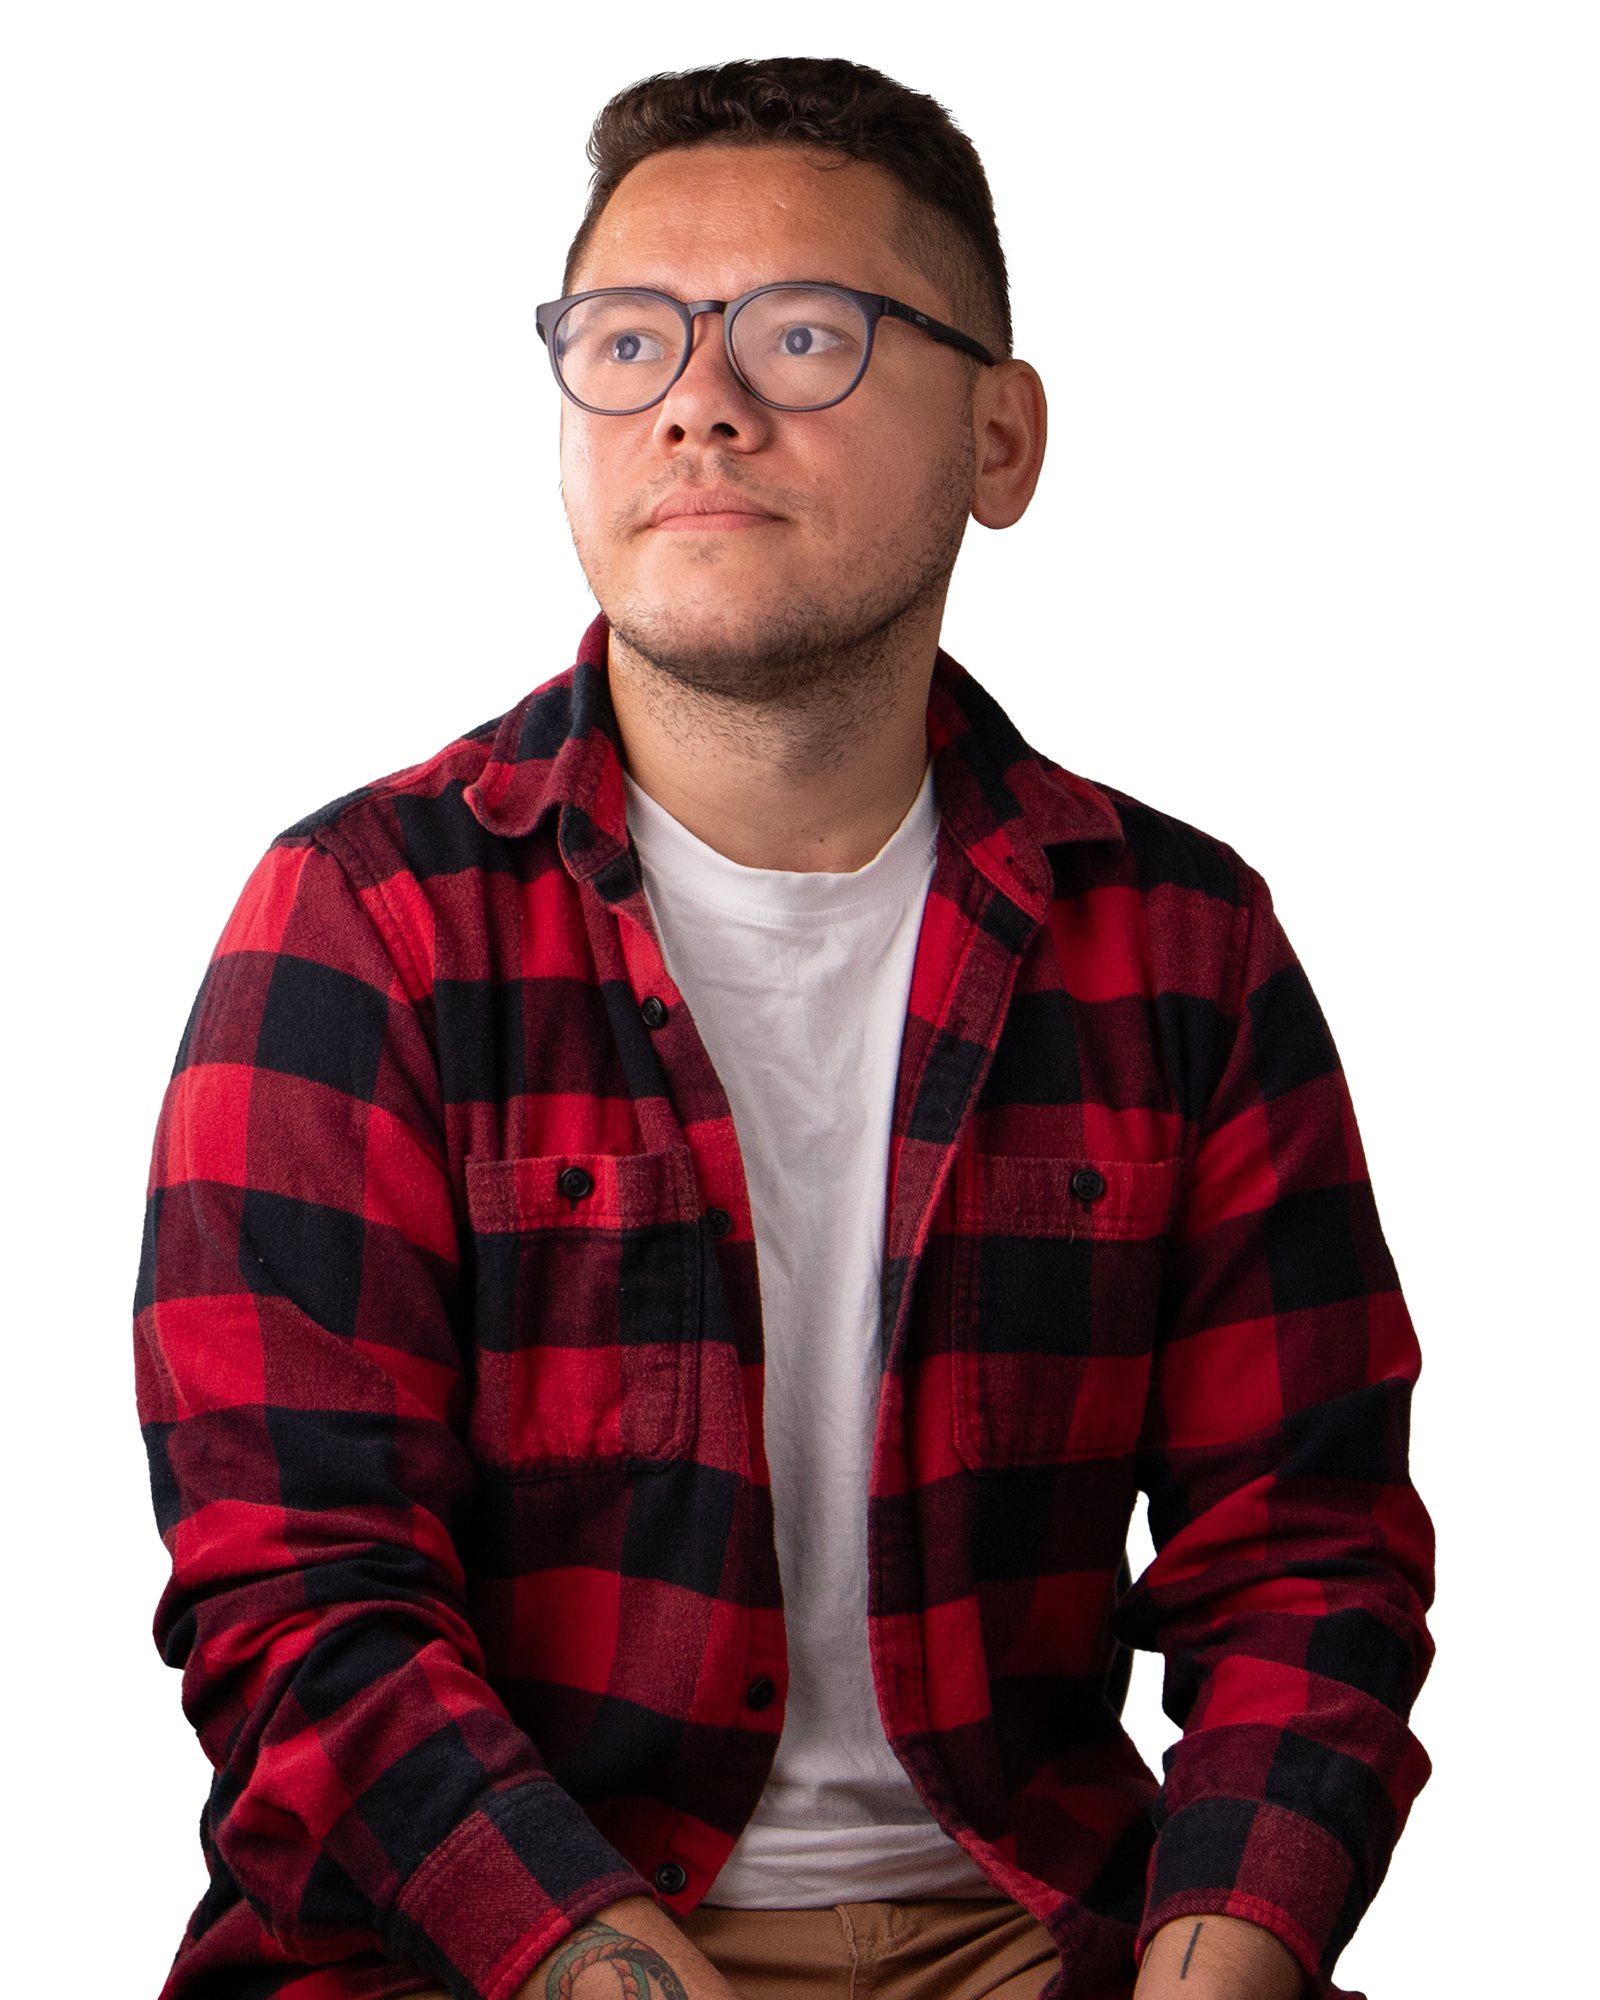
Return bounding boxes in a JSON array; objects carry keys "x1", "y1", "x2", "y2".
[{"x1": 562, "y1": 56, "x2": 1012, "y2": 368}]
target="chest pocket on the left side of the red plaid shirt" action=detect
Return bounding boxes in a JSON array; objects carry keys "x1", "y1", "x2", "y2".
[{"x1": 466, "y1": 1146, "x2": 702, "y2": 1478}]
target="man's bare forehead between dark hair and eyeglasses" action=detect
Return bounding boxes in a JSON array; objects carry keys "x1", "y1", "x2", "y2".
[{"x1": 574, "y1": 142, "x2": 920, "y2": 302}]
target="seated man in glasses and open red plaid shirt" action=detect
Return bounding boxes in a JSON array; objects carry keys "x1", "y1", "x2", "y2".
[{"x1": 140, "y1": 60, "x2": 1432, "y2": 2000}]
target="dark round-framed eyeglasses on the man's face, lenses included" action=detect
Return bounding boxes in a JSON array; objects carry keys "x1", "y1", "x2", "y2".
[{"x1": 534, "y1": 284, "x2": 994, "y2": 416}]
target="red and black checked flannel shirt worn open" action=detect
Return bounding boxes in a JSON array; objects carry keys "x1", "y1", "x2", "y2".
[{"x1": 138, "y1": 622, "x2": 1432, "y2": 2000}]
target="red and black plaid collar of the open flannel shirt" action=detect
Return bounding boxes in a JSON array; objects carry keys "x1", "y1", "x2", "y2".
[{"x1": 466, "y1": 616, "x2": 1122, "y2": 918}]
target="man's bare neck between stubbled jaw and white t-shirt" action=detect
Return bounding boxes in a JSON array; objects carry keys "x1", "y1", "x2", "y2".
[{"x1": 608, "y1": 624, "x2": 938, "y2": 874}]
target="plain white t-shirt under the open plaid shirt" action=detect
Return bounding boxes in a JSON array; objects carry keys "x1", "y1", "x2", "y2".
[{"x1": 628, "y1": 770, "x2": 996, "y2": 1910}]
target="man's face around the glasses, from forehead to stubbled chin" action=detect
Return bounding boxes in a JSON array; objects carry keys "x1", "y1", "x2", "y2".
[{"x1": 562, "y1": 144, "x2": 976, "y2": 702}]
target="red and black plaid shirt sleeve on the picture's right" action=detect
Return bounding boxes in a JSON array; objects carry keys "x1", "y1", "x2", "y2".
[{"x1": 1116, "y1": 870, "x2": 1434, "y2": 1992}]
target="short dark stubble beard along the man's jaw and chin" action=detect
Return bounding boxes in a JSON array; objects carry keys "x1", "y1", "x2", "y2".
[{"x1": 574, "y1": 428, "x2": 976, "y2": 768}]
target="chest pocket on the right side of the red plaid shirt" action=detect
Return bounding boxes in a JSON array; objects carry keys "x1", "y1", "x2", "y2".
[{"x1": 950, "y1": 1154, "x2": 1178, "y2": 1472}]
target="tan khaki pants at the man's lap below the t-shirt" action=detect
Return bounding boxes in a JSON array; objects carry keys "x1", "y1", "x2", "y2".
[{"x1": 678, "y1": 1900, "x2": 1134, "y2": 2000}]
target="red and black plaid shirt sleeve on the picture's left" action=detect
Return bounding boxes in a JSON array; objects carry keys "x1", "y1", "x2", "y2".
[{"x1": 136, "y1": 838, "x2": 648, "y2": 2000}]
